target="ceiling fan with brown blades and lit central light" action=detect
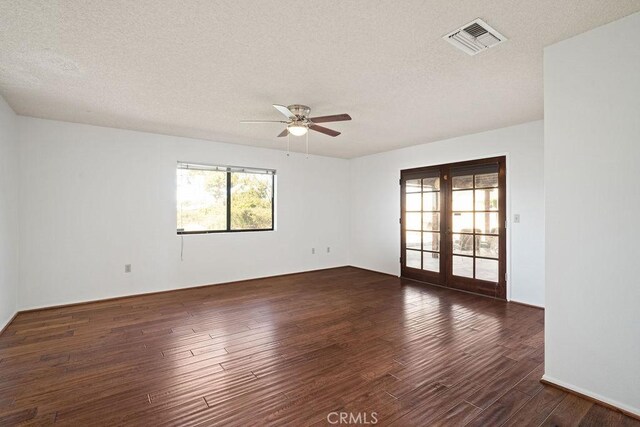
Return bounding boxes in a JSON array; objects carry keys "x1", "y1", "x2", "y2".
[{"x1": 240, "y1": 104, "x2": 351, "y2": 137}]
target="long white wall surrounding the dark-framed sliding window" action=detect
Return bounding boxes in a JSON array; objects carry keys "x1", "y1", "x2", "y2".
[{"x1": 19, "y1": 117, "x2": 349, "y2": 309}]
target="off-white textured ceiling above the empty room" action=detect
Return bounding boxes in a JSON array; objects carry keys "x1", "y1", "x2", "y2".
[{"x1": 0, "y1": 0, "x2": 640, "y2": 158}]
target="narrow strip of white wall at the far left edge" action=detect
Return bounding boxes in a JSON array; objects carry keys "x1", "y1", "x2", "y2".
[{"x1": 0, "y1": 97, "x2": 19, "y2": 329}]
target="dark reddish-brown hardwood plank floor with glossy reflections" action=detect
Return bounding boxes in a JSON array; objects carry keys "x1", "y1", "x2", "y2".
[{"x1": 0, "y1": 267, "x2": 640, "y2": 426}]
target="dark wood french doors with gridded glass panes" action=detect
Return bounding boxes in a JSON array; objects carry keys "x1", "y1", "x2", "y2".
[{"x1": 400, "y1": 157, "x2": 507, "y2": 299}]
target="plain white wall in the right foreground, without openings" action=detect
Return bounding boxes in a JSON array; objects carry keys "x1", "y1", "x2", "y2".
[{"x1": 544, "y1": 13, "x2": 640, "y2": 415}]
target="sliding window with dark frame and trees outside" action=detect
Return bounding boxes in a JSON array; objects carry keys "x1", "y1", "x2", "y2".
[{"x1": 176, "y1": 163, "x2": 276, "y2": 234}]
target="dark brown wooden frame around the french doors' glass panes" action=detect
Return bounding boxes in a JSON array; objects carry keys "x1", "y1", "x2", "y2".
[{"x1": 400, "y1": 155, "x2": 509, "y2": 300}]
